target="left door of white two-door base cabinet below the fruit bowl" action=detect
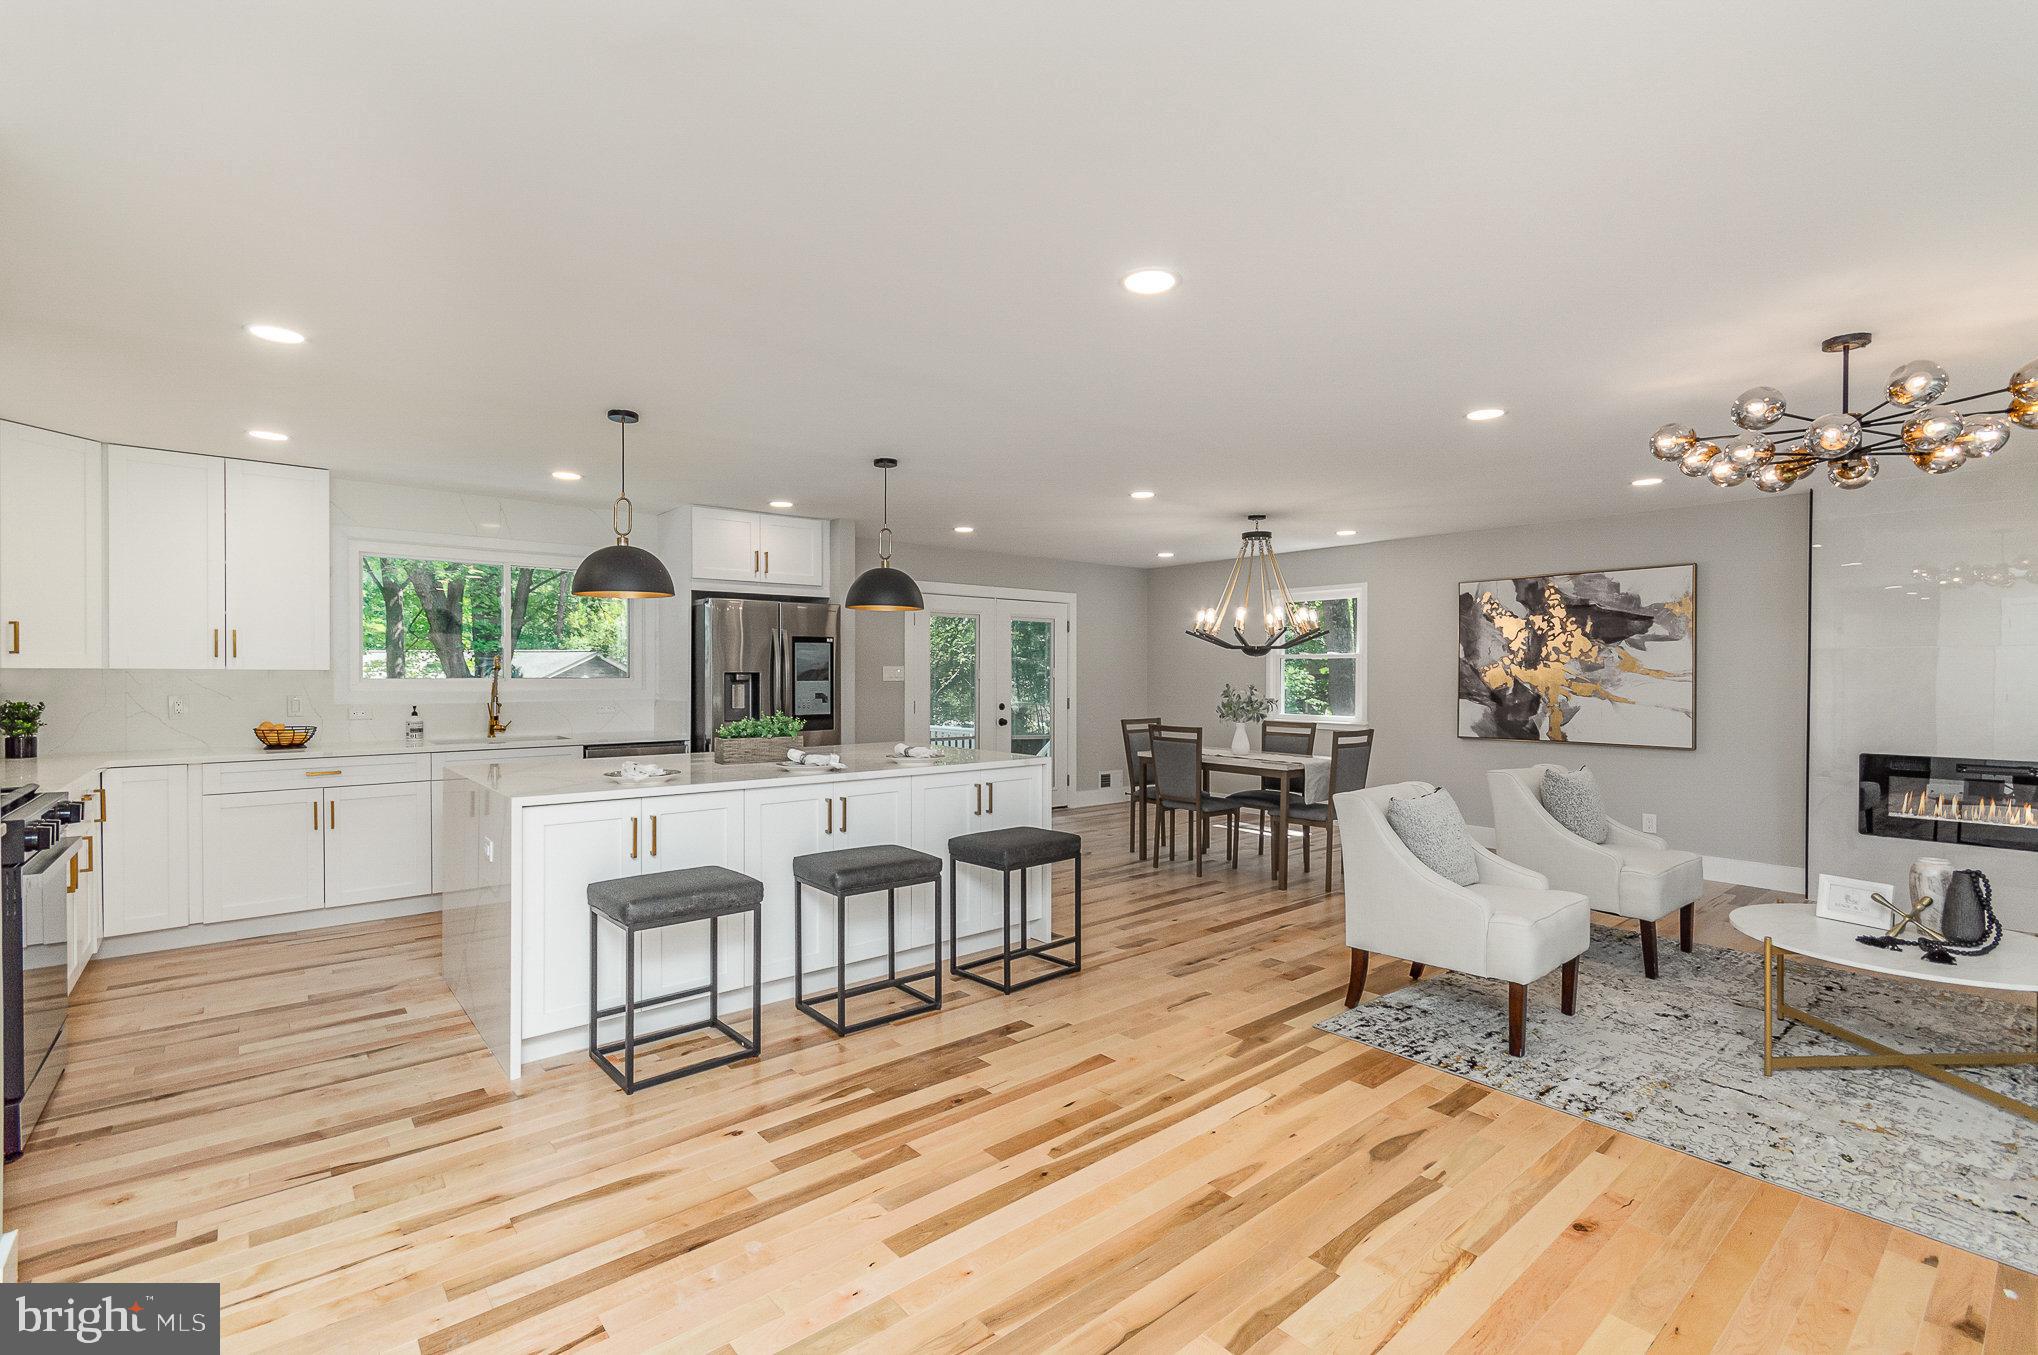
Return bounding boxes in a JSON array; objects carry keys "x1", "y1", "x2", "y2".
[{"x1": 200, "y1": 789, "x2": 326, "y2": 923}]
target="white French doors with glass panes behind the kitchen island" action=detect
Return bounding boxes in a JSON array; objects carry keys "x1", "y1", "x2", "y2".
[{"x1": 907, "y1": 593, "x2": 1074, "y2": 805}]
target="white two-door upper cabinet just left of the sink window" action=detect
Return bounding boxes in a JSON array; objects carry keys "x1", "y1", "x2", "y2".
[{"x1": 106, "y1": 446, "x2": 332, "y2": 668}]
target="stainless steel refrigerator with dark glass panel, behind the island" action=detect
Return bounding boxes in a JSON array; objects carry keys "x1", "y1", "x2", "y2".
[{"x1": 693, "y1": 597, "x2": 842, "y2": 752}]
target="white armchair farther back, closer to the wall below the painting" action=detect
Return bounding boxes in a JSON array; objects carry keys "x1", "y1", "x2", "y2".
[{"x1": 1486, "y1": 762, "x2": 1706, "y2": 978}]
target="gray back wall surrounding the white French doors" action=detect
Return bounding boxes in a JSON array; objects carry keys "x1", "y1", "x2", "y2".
[{"x1": 852, "y1": 538, "x2": 1151, "y2": 803}]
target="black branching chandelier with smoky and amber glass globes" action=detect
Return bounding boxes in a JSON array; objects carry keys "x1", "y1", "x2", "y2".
[{"x1": 1649, "y1": 334, "x2": 2038, "y2": 493}]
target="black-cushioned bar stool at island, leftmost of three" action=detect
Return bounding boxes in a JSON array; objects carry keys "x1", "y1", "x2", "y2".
[{"x1": 587, "y1": 866, "x2": 764, "y2": 1094}]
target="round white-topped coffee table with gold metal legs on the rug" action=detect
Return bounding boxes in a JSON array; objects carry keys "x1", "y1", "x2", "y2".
[{"x1": 1728, "y1": 903, "x2": 2038, "y2": 1121}]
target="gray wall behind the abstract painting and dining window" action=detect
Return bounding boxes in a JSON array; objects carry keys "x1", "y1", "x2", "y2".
[{"x1": 1157, "y1": 497, "x2": 1810, "y2": 882}]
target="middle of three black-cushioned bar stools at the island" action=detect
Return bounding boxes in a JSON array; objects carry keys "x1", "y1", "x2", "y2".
[{"x1": 793, "y1": 844, "x2": 942, "y2": 1035}]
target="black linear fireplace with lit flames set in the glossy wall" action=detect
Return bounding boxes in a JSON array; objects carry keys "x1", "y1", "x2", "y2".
[{"x1": 1861, "y1": 752, "x2": 2038, "y2": 852}]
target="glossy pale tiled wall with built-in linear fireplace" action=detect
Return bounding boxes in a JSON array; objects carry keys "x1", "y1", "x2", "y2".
[{"x1": 1808, "y1": 452, "x2": 2038, "y2": 931}]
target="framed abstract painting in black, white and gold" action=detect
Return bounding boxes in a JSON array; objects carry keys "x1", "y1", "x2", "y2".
[{"x1": 1457, "y1": 564, "x2": 1698, "y2": 748}]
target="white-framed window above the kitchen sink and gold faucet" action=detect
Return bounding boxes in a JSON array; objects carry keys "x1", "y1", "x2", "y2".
[{"x1": 351, "y1": 542, "x2": 634, "y2": 693}]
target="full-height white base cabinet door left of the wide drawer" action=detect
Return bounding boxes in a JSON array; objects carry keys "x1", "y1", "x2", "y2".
[{"x1": 96, "y1": 764, "x2": 194, "y2": 937}]
